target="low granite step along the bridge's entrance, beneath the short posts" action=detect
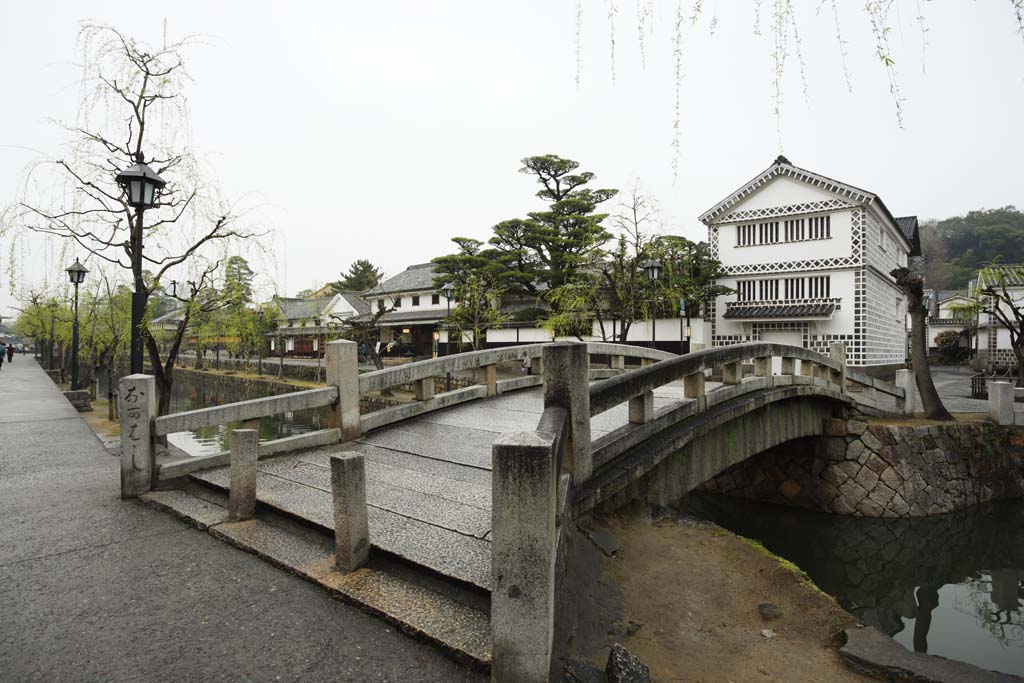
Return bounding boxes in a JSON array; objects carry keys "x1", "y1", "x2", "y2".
[{"x1": 140, "y1": 483, "x2": 490, "y2": 671}]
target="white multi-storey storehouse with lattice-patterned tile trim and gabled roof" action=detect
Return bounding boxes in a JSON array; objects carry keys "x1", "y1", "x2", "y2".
[{"x1": 700, "y1": 156, "x2": 921, "y2": 366}]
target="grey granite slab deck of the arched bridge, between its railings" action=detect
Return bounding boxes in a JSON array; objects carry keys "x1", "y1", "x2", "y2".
[{"x1": 191, "y1": 383, "x2": 696, "y2": 590}]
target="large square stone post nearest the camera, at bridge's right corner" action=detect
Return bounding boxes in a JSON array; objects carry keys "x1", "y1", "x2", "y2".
[{"x1": 490, "y1": 430, "x2": 557, "y2": 683}]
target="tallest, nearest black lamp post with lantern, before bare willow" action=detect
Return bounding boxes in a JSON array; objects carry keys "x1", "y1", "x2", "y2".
[{"x1": 117, "y1": 152, "x2": 167, "y2": 375}]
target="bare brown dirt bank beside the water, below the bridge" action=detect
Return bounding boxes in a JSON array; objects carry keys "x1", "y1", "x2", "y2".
[{"x1": 573, "y1": 512, "x2": 873, "y2": 683}]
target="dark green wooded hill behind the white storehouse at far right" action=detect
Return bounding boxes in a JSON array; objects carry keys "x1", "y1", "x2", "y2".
[{"x1": 921, "y1": 206, "x2": 1024, "y2": 290}]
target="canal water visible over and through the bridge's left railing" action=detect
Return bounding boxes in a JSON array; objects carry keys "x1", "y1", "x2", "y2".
[{"x1": 168, "y1": 374, "x2": 325, "y2": 456}]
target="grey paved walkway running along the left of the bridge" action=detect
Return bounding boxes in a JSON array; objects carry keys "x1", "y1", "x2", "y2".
[{"x1": 0, "y1": 356, "x2": 485, "y2": 683}]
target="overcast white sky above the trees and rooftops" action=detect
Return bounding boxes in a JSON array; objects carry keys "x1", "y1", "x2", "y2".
[{"x1": 0, "y1": 0, "x2": 1024, "y2": 315}]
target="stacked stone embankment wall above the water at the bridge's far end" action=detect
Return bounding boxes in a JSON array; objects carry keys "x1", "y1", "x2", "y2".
[{"x1": 703, "y1": 419, "x2": 1024, "y2": 517}]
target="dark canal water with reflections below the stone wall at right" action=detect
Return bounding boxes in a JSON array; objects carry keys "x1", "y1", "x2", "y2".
[{"x1": 681, "y1": 494, "x2": 1024, "y2": 675}]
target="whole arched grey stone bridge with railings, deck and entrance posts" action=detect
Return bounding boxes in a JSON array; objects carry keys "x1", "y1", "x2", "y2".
[{"x1": 120, "y1": 342, "x2": 913, "y2": 681}]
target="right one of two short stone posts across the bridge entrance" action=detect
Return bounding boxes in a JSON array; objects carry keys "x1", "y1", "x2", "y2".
[{"x1": 331, "y1": 453, "x2": 370, "y2": 572}]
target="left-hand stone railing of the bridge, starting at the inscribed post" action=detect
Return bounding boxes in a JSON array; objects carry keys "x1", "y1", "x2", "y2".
[{"x1": 119, "y1": 340, "x2": 675, "y2": 498}]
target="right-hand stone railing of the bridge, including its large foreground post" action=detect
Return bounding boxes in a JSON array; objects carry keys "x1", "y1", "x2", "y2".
[{"x1": 490, "y1": 343, "x2": 914, "y2": 682}]
